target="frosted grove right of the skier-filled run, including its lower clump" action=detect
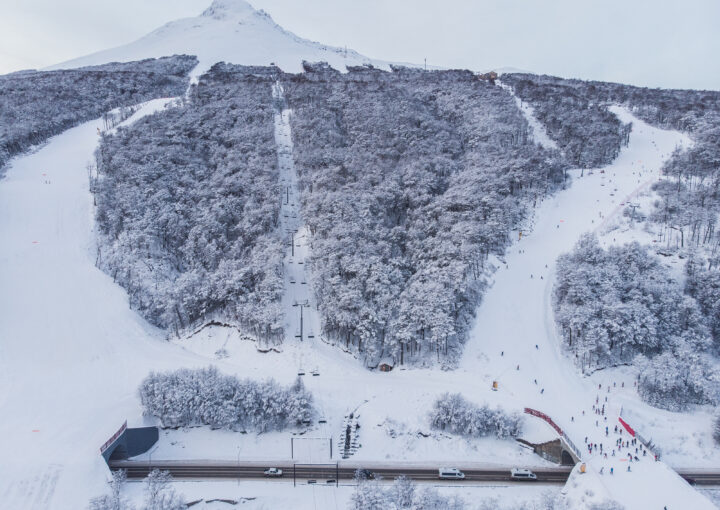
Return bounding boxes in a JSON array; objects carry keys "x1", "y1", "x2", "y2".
[{"x1": 554, "y1": 234, "x2": 720, "y2": 409}]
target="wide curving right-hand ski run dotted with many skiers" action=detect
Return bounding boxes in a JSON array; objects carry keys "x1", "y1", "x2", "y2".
[{"x1": 461, "y1": 107, "x2": 714, "y2": 510}]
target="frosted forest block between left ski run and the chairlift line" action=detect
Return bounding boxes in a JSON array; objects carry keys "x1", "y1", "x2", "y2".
[{"x1": 93, "y1": 64, "x2": 283, "y2": 341}]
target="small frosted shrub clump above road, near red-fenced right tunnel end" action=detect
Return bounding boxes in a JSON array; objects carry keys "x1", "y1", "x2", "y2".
[{"x1": 430, "y1": 393, "x2": 522, "y2": 438}]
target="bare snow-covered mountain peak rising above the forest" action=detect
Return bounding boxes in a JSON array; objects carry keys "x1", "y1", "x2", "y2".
[{"x1": 48, "y1": 0, "x2": 388, "y2": 72}]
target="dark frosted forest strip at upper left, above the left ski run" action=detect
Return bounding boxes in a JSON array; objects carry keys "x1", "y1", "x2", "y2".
[{"x1": 0, "y1": 55, "x2": 197, "y2": 175}]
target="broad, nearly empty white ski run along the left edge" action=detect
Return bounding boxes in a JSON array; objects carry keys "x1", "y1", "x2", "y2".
[{"x1": 0, "y1": 100, "x2": 217, "y2": 509}]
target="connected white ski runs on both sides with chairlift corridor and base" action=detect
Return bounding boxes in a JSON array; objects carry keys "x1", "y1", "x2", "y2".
[{"x1": 0, "y1": 82, "x2": 712, "y2": 510}]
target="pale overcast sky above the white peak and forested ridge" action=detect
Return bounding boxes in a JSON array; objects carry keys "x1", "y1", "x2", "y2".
[{"x1": 0, "y1": 0, "x2": 720, "y2": 89}]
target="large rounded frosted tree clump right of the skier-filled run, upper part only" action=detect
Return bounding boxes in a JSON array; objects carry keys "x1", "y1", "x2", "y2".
[{"x1": 553, "y1": 234, "x2": 710, "y2": 371}]
